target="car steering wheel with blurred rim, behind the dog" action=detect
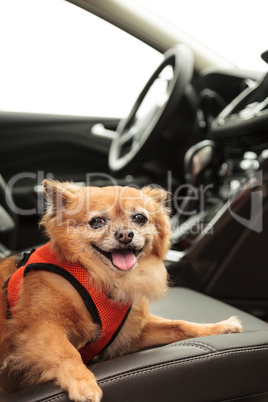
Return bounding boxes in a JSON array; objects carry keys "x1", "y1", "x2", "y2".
[{"x1": 109, "y1": 45, "x2": 194, "y2": 172}]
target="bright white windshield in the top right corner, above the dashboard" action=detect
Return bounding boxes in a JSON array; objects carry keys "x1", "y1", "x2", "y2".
[{"x1": 136, "y1": 0, "x2": 268, "y2": 71}]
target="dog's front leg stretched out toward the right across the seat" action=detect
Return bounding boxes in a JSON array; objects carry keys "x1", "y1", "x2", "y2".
[{"x1": 131, "y1": 314, "x2": 242, "y2": 350}]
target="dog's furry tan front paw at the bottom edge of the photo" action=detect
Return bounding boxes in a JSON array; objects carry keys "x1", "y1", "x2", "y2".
[{"x1": 68, "y1": 378, "x2": 102, "y2": 402}]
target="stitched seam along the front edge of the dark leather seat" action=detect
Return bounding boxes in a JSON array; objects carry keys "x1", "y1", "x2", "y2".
[{"x1": 98, "y1": 347, "x2": 268, "y2": 384}]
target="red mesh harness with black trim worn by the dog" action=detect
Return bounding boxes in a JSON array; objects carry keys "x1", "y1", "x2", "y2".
[{"x1": 7, "y1": 243, "x2": 131, "y2": 364}]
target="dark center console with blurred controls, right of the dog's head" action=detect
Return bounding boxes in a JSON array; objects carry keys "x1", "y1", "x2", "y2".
[{"x1": 167, "y1": 137, "x2": 268, "y2": 318}]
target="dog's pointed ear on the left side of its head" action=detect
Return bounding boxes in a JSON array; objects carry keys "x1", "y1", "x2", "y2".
[{"x1": 43, "y1": 180, "x2": 80, "y2": 213}]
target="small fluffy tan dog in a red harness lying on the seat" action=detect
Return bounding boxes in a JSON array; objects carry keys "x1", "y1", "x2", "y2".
[{"x1": 0, "y1": 180, "x2": 242, "y2": 402}]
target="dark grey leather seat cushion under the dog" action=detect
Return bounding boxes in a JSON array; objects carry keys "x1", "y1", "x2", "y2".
[{"x1": 1, "y1": 288, "x2": 268, "y2": 402}]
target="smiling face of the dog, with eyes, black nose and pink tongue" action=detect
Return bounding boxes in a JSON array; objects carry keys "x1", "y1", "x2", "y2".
[{"x1": 88, "y1": 202, "x2": 151, "y2": 271}]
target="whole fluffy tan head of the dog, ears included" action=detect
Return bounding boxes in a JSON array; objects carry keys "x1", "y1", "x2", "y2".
[{"x1": 41, "y1": 180, "x2": 170, "y2": 297}]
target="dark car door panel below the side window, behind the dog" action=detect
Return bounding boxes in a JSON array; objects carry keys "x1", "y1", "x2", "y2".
[{"x1": 0, "y1": 112, "x2": 118, "y2": 248}]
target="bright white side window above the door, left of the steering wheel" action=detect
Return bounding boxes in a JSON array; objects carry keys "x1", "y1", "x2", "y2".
[{"x1": 0, "y1": 0, "x2": 162, "y2": 117}]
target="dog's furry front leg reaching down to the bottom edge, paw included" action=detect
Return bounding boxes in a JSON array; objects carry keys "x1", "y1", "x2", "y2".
[{"x1": 6, "y1": 324, "x2": 102, "y2": 402}]
